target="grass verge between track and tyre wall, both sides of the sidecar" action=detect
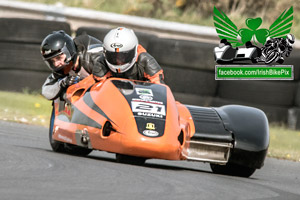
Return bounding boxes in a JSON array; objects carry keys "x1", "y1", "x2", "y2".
[{"x1": 0, "y1": 91, "x2": 300, "y2": 161}]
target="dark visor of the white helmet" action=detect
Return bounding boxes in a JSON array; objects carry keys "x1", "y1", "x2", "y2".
[{"x1": 105, "y1": 48, "x2": 136, "y2": 65}]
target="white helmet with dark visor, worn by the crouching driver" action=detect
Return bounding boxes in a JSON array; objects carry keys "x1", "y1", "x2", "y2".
[{"x1": 103, "y1": 27, "x2": 138, "y2": 73}]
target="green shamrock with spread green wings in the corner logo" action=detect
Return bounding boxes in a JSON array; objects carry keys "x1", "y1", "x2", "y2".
[{"x1": 214, "y1": 7, "x2": 293, "y2": 47}]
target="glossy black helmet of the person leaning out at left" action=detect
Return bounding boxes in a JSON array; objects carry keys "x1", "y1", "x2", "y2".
[{"x1": 41, "y1": 30, "x2": 77, "y2": 72}]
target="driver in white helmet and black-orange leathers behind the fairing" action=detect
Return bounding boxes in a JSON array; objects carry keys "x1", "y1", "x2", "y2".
[{"x1": 93, "y1": 27, "x2": 164, "y2": 83}]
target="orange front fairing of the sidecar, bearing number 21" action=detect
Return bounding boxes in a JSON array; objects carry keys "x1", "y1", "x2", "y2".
[{"x1": 53, "y1": 76, "x2": 195, "y2": 160}]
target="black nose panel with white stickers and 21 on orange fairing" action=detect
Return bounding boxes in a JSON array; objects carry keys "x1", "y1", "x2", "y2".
[{"x1": 112, "y1": 80, "x2": 168, "y2": 137}]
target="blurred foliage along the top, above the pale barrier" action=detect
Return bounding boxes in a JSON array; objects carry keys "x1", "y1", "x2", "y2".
[{"x1": 18, "y1": 0, "x2": 300, "y2": 38}]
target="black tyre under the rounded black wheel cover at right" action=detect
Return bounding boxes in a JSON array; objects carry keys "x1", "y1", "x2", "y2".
[{"x1": 210, "y1": 163, "x2": 256, "y2": 178}]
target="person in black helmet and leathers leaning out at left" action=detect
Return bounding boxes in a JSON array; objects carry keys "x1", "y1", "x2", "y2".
[{"x1": 41, "y1": 31, "x2": 103, "y2": 100}]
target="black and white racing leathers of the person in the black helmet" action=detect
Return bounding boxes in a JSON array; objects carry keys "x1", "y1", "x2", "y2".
[{"x1": 42, "y1": 34, "x2": 103, "y2": 100}]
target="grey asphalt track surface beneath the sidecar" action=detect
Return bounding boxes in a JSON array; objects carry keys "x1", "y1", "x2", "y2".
[{"x1": 0, "y1": 121, "x2": 300, "y2": 200}]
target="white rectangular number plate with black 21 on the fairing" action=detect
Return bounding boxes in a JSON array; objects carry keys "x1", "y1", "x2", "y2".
[{"x1": 131, "y1": 101, "x2": 166, "y2": 116}]
